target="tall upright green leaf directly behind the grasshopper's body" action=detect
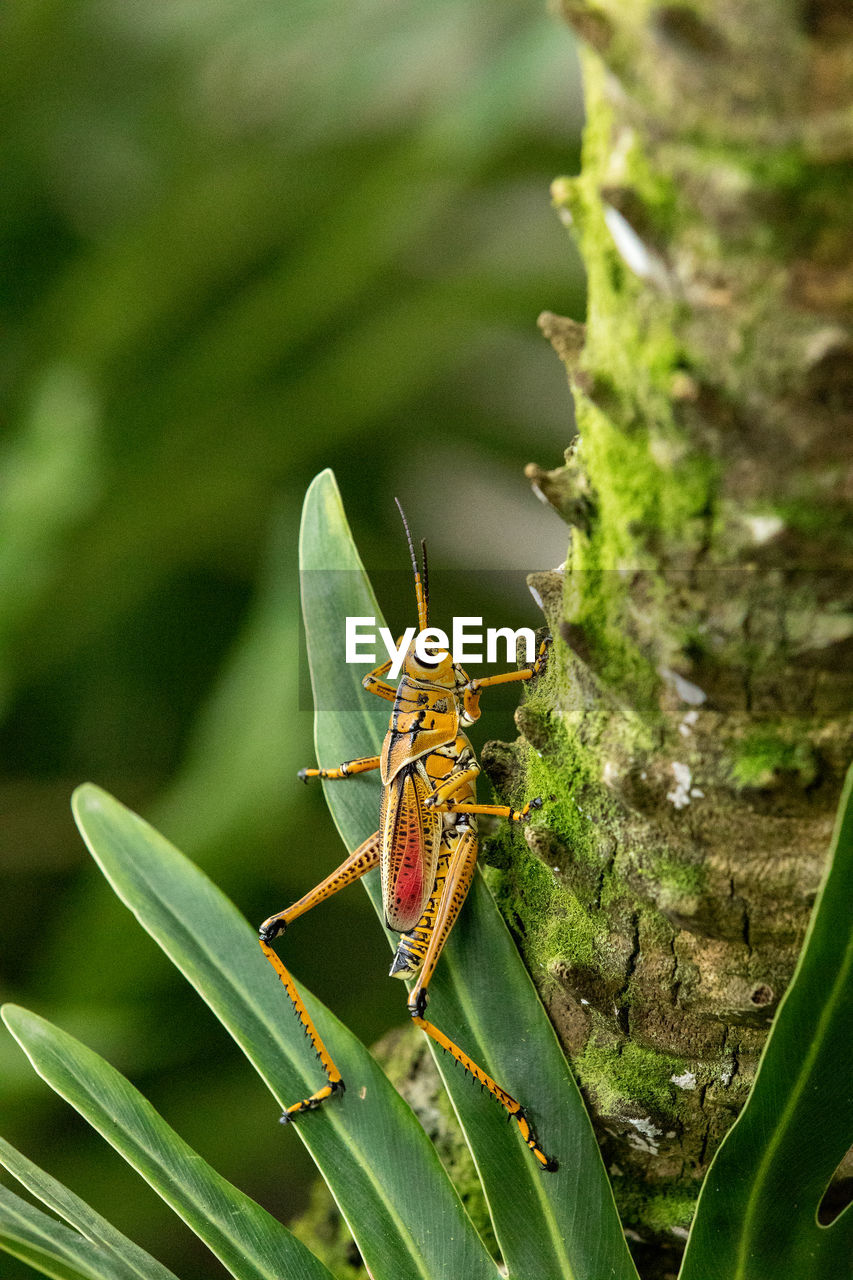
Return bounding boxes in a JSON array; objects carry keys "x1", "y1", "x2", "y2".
[{"x1": 300, "y1": 471, "x2": 637, "y2": 1280}]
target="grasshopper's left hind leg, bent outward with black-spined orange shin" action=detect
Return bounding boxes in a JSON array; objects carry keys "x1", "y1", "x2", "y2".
[{"x1": 260, "y1": 831, "x2": 379, "y2": 1121}]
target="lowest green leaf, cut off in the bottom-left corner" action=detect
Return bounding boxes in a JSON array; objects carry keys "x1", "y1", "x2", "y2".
[{"x1": 0, "y1": 1187, "x2": 128, "y2": 1280}]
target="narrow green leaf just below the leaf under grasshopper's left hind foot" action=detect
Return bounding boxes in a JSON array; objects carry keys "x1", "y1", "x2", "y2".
[{"x1": 3, "y1": 1005, "x2": 338, "y2": 1280}]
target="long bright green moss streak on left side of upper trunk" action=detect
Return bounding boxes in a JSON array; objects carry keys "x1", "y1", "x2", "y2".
[{"x1": 555, "y1": 60, "x2": 719, "y2": 718}]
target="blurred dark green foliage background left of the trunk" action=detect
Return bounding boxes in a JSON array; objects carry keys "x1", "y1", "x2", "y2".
[{"x1": 0, "y1": 0, "x2": 583, "y2": 1280}]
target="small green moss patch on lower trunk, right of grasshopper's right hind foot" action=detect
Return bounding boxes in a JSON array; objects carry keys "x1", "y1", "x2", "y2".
[{"x1": 574, "y1": 1041, "x2": 684, "y2": 1115}]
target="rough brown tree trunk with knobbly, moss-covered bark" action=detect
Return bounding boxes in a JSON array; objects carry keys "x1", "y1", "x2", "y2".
[{"x1": 484, "y1": 0, "x2": 853, "y2": 1275}]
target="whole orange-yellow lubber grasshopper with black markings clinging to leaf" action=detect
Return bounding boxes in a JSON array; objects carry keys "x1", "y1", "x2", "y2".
[{"x1": 260, "y1": 503, "x2": 557, "y2": 1171}]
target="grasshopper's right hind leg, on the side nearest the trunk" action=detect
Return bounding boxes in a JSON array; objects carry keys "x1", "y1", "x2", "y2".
[{"x1": 402, "y1": 817, "x2": 557, "y2": 1172}]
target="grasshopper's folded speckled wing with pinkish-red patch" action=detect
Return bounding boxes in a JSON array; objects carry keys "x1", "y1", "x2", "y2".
[{"x1": 379, "y1": 762, "x2": 442, "y2": 933}]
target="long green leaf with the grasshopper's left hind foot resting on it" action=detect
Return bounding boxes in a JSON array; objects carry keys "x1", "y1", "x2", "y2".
[{"x1": 74, "y1": 780, "x2": 496, "y2": 1280}]
